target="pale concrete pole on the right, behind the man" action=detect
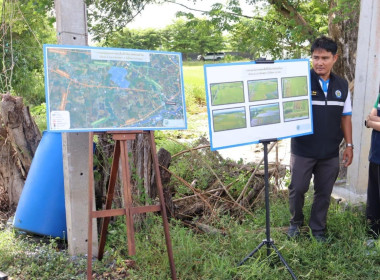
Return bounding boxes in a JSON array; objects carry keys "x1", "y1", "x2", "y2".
[{"x1": 345, "y1": 0, "x2": 380, "y2": 201}]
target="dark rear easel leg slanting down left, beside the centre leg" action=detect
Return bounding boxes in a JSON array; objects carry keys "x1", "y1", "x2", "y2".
[{"x1": 98, "y1": 141, "x2": 120, "y2": 260}]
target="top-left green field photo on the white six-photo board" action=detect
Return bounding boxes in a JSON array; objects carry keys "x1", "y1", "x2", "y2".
[{"x1": 210, "y1": 82, "x2": 244, "y2": 106}]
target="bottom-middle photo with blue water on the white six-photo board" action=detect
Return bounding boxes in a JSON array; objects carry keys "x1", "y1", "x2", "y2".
[{"x1": 249, "y1": 103, "x2": 281, "y2": 126}]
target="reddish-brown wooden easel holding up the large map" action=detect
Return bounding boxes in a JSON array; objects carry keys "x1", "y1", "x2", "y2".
[{"x1": 87, "y1": 131, "x2": 177, "y2": 279}]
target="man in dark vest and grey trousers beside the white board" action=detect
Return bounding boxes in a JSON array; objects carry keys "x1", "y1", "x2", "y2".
[{"x1": 288, "y1": 37, "x2": 354, "y2": 241}]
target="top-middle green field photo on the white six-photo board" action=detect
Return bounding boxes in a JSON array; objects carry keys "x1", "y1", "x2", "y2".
[{"x1": 248, "y1": 79, "x2": 278, "y2": 102}]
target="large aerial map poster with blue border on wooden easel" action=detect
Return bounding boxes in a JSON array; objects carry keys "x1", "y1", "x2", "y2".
[{"x1": 44, "y1": 45, "x2": 187, "y2": 132}]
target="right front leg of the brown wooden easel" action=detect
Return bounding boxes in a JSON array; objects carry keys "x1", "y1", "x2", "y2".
[{"x1": 150, "y1": 131, "x2": 177, "y2": 280}]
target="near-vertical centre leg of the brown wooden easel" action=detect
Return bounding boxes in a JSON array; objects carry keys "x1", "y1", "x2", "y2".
[{"x1": 120, "y1": 140, "x2": 136, "y2": 256}]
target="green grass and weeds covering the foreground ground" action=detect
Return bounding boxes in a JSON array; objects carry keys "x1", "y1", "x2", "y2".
[{"x1": 0, "y1": 193, "x2": 380, "y2": 280}]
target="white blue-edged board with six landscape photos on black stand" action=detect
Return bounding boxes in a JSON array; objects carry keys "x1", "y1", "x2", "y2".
[{"x1": 204, "y1": 59, "x2": 313, "y2": 150}]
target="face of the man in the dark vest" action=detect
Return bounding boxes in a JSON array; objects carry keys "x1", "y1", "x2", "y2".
[{"x1": 311, "y1": 49, "x2": 338, "y2": 80}]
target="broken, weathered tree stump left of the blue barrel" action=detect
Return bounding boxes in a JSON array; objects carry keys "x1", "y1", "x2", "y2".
[{"x1": 0, "y1": 94, "x2": 41, "y2": 206}]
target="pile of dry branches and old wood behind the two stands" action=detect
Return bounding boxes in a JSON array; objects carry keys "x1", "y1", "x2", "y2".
[{"x1": 96, "y1": 138, "x2": 286, "y2": 231}]
